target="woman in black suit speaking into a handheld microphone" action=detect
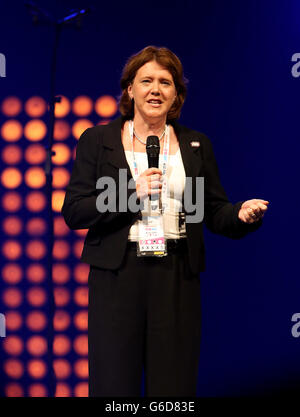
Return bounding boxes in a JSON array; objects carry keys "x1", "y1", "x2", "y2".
[{"x1": 62, "y1": 46, "x2": 268, "y2": 396}]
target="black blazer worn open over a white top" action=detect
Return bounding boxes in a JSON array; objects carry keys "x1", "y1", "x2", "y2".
[{"x1": 62, "y1": 117, "x2": 262, "y2": 273}]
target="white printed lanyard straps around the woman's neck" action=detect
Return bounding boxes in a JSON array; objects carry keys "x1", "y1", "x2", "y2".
[{"x1": 129, "y1": 120, "x2": 170, "y2": 212}]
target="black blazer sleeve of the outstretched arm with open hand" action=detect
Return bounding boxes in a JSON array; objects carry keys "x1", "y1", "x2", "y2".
[{"x1": 202, "y1": 136, "x2": 262, "y2": 239}]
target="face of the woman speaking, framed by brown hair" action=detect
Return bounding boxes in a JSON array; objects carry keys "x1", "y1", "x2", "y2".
[{"x1": 128, "y1": 61, "x2": 176, "y2": 119}]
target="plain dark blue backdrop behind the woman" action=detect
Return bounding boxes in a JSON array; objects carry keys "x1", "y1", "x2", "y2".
[{"x1": 0, "y1": 0, "x2": 300, "y2": 396}]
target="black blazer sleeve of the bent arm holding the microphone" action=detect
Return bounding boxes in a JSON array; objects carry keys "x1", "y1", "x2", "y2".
[{"x1": 62, "y1": 128, "x2": 139, "y2": 230}]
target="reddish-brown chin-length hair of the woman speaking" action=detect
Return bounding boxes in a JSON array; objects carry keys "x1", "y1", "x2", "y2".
[{"x1": 119, "y1": 46, "x2": 187, "y2": 120}]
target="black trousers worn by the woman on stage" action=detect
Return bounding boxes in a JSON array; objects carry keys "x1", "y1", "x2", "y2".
[{"x1": 88, "y1": 242, "x2": 201, "y2": 397}]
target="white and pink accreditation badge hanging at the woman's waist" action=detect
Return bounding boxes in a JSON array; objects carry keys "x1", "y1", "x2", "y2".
[{"x1": 137, "y1": 214, "x2": 167, "y2": 257}]
